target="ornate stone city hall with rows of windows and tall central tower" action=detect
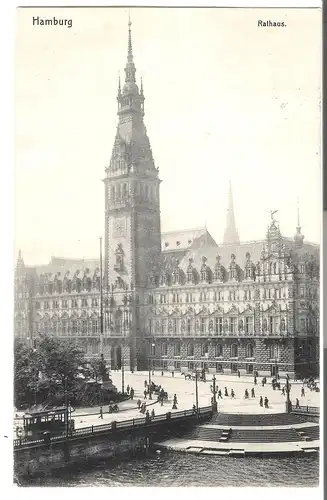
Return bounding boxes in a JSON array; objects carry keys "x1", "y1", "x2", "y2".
[{"x1": 14, "y1": 24, "x2": 319, "y2": 376}]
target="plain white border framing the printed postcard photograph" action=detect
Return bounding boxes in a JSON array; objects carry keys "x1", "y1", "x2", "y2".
[{"x1": 0, "y1": 0, "x2": 324, "y2": 500}]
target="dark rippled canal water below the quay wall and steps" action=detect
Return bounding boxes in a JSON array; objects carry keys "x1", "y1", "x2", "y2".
[{"x1": 22, "y1": 453, "x2": 319, "y2": 487}]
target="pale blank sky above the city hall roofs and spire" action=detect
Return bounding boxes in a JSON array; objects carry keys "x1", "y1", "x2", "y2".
[{"x1": 15, "y1": 8, "x2": 321, "y2": 265}]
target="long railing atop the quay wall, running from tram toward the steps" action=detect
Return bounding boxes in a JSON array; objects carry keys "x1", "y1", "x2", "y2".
[{"x1": 14, "y1": 406, "x2": 212, "y2": 449}]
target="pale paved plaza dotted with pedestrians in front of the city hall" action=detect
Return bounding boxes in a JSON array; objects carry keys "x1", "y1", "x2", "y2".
[{"x1": 15, "y1": 371, "x2": 320, "y2": 429}]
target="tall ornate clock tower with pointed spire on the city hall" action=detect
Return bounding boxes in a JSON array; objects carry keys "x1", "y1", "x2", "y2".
[{"x1": 104, "y1": 22, "x2": 161, "y2": 370}]
